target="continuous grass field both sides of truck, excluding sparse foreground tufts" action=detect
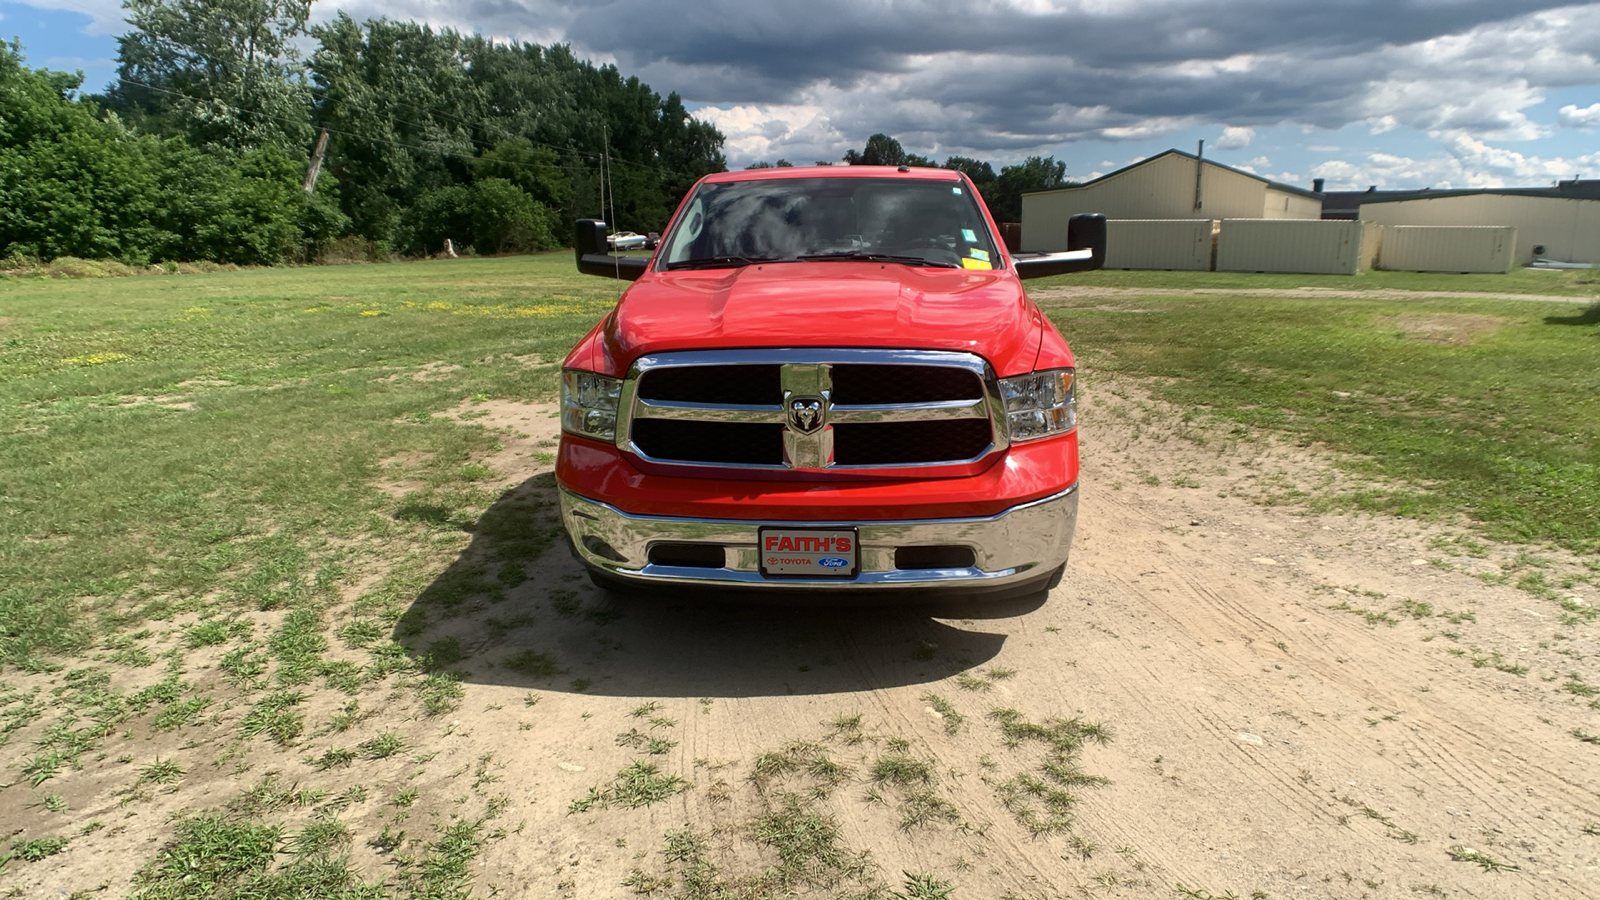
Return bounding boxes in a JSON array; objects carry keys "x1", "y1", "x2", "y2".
[{"x1": 0, "y1": 253, "x2": 1600, "y2": 663}]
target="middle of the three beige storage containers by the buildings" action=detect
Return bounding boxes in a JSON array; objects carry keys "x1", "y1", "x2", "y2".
[{"x1": 1216, "y1": 219, "x2": 1366, "y2": 275}]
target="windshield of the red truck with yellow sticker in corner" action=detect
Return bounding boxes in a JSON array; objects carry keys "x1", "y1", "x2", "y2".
[{"x1": 662, "y1": 178, "x2": 1000, "y2": 269}]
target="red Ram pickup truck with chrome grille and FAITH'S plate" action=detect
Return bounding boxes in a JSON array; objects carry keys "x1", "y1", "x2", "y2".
[{"x1": 555, "y1": 167, "x2": 1106, "y2": 596}]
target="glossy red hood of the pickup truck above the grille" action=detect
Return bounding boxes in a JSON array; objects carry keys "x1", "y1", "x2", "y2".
[{"x1": 590, "y1": 261, "x2": 1043, "y2": 376}]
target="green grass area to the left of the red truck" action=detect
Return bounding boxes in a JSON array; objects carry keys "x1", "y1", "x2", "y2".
[{"x1": 0, "y1": 253, "x2": 619, "y2": 663}]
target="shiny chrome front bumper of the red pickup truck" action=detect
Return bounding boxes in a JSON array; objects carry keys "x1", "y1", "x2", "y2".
[{"x1": 562, "y1": 485, "x2": 1078, "y2": 591}]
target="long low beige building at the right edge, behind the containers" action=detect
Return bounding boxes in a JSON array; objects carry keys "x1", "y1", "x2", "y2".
[{"x1": 1363, "y1": 194, "x2": 1600, "y2": 263}]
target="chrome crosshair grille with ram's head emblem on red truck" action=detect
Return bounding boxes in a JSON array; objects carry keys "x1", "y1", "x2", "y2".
[{"x1": 618, "y1": 349, "x2": 1005, "y2": 471}]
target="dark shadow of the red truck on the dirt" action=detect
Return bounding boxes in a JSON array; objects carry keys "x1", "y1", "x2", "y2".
[{"x1": 394, "y1": 474, "x2": 1011, "y2": 698}]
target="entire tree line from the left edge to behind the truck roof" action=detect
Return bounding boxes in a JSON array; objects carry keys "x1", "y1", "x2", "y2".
[{"x1": 0, "y1": 0, "x2": 1067, "y2": 264}]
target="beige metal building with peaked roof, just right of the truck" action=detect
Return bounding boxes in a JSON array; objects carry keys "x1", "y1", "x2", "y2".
[{"x1": 1022, "y1": 151, "x2": 1322, "y2": 251}]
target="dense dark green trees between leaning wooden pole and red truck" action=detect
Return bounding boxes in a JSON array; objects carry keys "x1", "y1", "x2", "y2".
[{"x1": 310, "y1": 13, "x2": 726, "y2": 241}]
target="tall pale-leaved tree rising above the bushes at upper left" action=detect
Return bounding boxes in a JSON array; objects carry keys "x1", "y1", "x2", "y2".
[{"x1": 107, "y1": 0, "x2": 312, "y2": 157}]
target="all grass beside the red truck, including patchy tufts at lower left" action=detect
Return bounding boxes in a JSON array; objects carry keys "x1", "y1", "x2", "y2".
[{"x1": 0, "y1": 253, "x2": 1600, "y2": 897}]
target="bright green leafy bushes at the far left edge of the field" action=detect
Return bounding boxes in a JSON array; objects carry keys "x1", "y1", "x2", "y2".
[{"x1": 0, "y1": 43, "x2": 350, "y2": 265}]
